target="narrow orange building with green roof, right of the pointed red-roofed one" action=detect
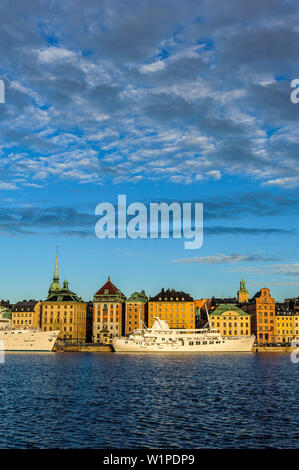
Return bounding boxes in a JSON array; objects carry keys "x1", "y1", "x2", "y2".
[{"x1": 125, "y1": 290, "x2": 148, "y2": 335}]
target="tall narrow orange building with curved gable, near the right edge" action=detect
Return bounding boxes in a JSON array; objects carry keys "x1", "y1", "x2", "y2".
[{"x1": 241, "y1": 287, "x2": 276, "y2": 344}]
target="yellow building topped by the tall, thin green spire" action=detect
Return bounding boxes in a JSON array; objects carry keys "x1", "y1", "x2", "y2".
[{"x1": 41, "y1": 248, "x2": 87, "y2": 343}]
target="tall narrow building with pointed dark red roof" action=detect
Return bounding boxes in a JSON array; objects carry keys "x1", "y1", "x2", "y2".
[{"x1": 92, "y1": 277, "x2": 126, "y2": 344}]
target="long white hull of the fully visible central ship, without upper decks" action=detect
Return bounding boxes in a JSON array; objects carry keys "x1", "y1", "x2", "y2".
[{"x1": 113, "y1": 336, "x2": 255, "y2": 353}]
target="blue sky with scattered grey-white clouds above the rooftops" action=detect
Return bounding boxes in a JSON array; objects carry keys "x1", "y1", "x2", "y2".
[{"x1": 0, "y1": 0, "x2": 299, "y2": 302}]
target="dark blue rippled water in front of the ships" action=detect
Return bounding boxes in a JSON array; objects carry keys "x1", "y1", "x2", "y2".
[{"x1": 0, "y1": 353, "x2": 299, "y2": 449}]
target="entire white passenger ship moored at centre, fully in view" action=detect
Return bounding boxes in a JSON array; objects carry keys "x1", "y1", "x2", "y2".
[{"x1": 113, "y1": 318, "x2": 255, "y2": 353}]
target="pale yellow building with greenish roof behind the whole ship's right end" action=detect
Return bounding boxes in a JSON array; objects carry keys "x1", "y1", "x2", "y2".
[{"x1": 209, "y1": 304, "x2": 251, "y2": 337}]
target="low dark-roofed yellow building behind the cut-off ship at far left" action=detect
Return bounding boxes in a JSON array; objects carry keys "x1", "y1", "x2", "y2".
[{"x1": 11, "y1": 300, "x2": 42, "y2": 329}]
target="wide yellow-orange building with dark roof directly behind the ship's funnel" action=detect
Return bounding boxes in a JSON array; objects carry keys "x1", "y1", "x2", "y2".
[{"x1": 148, "y1": 289, "x2": 195, "y2": 329}]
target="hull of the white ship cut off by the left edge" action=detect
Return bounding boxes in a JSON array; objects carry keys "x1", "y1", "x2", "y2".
[{"x1": 0, "y1": 330, "x2": 60, "y2": 352}]
